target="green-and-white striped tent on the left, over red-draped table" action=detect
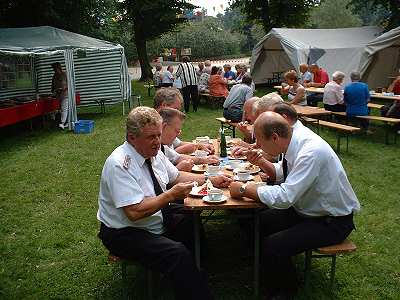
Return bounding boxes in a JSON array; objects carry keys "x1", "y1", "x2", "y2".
[{"x1": 0, "y1": 26, "x2": 131, "y2": 129}]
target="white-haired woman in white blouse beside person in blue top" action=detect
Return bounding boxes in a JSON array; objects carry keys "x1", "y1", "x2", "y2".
[{"x1": 323, "y1": 71, "x2": 346, "y2": 111}]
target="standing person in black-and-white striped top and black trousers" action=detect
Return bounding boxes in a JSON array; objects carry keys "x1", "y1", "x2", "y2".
[{"x1": 175, "y1": 56, "x2": 199, "y2": 113}]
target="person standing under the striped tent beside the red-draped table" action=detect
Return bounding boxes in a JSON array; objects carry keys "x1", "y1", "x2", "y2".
[{"x1": 51, "y1": 62, "x2": 68, "y2": 129}]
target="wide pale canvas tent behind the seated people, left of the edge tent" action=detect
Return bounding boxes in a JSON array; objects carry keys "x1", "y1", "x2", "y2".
[{"x1": 251, "y1": 26, "x2": 382, "y2": 84}]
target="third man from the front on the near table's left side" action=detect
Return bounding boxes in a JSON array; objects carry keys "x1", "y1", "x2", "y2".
[{"x1": 153, "y1": 88, "x2": 214, "y2": 154}]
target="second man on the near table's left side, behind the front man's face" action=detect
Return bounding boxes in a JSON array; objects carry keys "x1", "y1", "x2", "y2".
[{"x1": 158, "y1": 107, "x2": 219, "y2": 172}]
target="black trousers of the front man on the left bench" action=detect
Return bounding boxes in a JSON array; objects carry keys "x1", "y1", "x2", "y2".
[{"x1": 99, "y1": 209, "x2": 213, "y2": 300}]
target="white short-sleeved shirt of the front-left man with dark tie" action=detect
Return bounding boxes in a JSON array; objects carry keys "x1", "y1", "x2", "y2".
[{"x1": 97, "y1": 142, "x2": 179, "y2": 234}]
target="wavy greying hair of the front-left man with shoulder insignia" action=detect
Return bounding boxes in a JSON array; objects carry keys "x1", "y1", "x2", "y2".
[{"x1": 126, "y1": 106, "x2": 162, "y2": 136}]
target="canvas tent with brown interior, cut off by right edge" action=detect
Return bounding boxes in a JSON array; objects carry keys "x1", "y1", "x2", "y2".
[{"x1": 360, "y1": 27, "x2": 400, "y2": 88}]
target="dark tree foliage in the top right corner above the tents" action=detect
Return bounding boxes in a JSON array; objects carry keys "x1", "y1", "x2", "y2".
[{"x1": 350, "y1": 0, "x2": 400, "y2": 30}]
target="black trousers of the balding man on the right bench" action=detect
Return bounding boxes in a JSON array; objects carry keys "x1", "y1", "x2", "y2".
[{"x1": 260, "y1": 208, "x2": 354, "y2": 291}]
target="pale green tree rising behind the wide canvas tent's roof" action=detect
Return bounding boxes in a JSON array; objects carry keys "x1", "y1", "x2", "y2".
[{"x1": 310, "y1": 0, "x2": 362, "y2": 28}]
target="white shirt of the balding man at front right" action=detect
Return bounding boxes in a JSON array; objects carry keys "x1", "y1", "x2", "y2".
[{"x1": 257, "y1": 126, "x2": 360, "y2": 217}]
